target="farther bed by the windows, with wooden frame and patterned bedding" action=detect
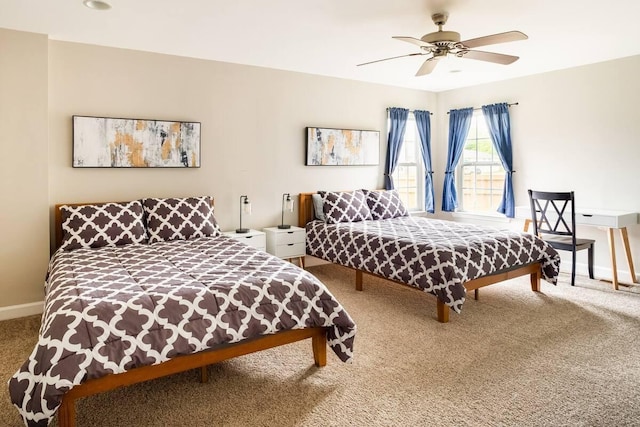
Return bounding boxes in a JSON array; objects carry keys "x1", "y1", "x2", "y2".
[{"x1": 298, "y1": 190, "x2": 560, "y2": 323}]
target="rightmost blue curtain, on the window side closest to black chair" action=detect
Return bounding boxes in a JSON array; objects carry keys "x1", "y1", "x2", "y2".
[{"x1": 482, "y1": 102, "x2": 515, "y2": 218}]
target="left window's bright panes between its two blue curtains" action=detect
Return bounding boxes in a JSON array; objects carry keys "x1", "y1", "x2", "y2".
[{"x1": 391, "y1": 113, "x2": 424, "y2": 211}]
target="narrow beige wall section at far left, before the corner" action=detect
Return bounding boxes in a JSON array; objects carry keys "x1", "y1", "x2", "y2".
[{"x1": 0, "y1": 29, "x2": 49, "y2": 307}]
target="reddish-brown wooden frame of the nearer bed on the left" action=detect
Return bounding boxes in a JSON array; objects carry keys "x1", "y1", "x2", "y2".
[{"x1": 55, "y1": 199, "x2": 327, "y2": 427}]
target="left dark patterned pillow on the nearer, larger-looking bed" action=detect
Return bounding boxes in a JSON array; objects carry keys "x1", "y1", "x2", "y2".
[{"x1": 60, "y1": 200, "x2": 147, "y2": 251}]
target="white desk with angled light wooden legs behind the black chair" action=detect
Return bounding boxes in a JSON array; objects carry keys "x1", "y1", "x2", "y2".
[{"x1": 516, "y1": 206, "x2": 638, "y2": 290}]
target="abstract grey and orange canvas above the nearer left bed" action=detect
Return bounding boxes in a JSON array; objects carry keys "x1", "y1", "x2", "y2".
[{"x1": 73, "y1": 116, "x2": 200, "y2": 168}]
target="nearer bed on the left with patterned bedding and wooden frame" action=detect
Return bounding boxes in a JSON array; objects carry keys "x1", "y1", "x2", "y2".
[{"x1": 9, "y1": 197, "x2": 356, "y2": 426}]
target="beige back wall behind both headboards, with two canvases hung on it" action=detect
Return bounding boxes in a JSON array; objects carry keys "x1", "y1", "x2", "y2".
[{"x1": 49, "y1": 41, "x2": 436, "y2": 239}]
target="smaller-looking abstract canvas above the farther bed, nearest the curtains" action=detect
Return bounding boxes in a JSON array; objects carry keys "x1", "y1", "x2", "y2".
[{"x1": 305, "y1": 127, "x2": 380, "y2": 166}]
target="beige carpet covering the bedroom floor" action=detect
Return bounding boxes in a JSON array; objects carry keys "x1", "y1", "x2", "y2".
[{"x1": 0, "y1": 265, "x2": 640, "y2": 427}]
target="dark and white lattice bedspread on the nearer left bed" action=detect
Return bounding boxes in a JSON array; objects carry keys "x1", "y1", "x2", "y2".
[{"x1": 9, "y1": 236, "x2": 356, "y2": 425}]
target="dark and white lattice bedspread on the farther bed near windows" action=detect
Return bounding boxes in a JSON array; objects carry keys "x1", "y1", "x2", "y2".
[{"x1": 306, "y1": 216, "x2": 560, "y2": 313}]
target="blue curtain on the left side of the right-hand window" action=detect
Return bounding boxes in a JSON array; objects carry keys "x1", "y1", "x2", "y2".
[{"x1": 442, "y1": 108, "x2": 473, "y2": 212}]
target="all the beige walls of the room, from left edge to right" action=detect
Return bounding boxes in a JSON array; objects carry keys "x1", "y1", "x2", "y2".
[{"x1": 0, "y1": 30, "x2": 640, "y2": 309}]
